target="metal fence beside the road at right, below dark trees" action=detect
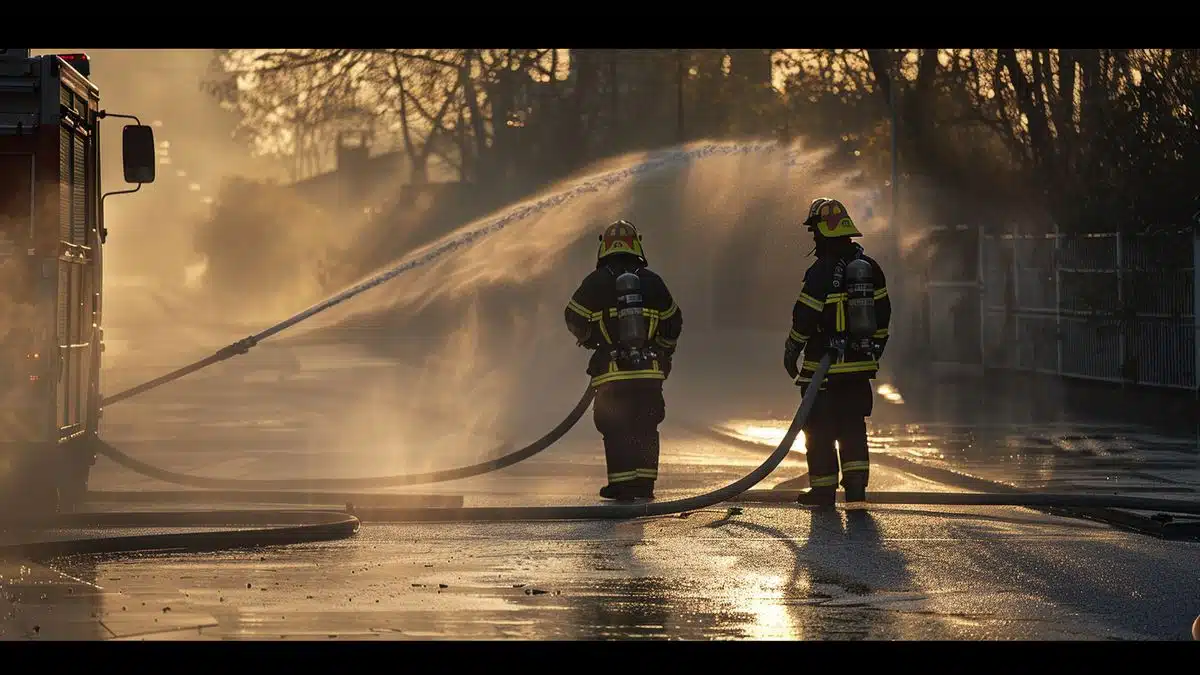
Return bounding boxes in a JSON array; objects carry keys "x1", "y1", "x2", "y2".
[{"x1": 926, "y1": 226, "x2": 1200, "y2": 390}]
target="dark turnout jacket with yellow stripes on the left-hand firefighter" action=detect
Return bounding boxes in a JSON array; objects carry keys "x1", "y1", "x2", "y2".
[{"x1": 564, "y1": 265, "x2": 683, "y2": 387}]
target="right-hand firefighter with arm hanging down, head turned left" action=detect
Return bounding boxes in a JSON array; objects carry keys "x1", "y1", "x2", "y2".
[{"x1": 784, "y1": 197, "x2": 892, "y2": 506}]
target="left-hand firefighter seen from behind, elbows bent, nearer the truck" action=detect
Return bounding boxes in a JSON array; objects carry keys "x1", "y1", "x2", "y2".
[{"x1": 564, "y1": 220, "x2": 683, "y2": 500}]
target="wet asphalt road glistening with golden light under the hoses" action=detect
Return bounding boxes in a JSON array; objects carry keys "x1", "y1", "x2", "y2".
[{"x1": 0, "y1": 338, "x2": 1200, "y2": 640}]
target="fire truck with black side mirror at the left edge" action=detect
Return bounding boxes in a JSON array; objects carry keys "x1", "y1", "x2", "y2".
[{"x1": 0, "y1": 49, "x2": 156, "y2": 514}]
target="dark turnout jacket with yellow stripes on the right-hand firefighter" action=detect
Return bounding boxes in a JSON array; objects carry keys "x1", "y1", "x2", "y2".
[{"x1": 787, "y1": 244, "x2": 892, "y2": 383}]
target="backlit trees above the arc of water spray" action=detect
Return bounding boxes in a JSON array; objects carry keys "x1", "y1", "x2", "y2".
[{"x1": 209, "y1": 49, "x2": 1200, "y2": 231}]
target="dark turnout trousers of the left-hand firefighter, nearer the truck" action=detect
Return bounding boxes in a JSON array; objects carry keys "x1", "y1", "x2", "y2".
[{"x1": 593, "y1": 380, "x2": 666, "y2": 495}]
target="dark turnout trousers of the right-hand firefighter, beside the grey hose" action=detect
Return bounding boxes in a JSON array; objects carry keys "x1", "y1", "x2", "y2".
[{"x1": 804, "y1": 377, "x2": 875, "y2": 503}]
